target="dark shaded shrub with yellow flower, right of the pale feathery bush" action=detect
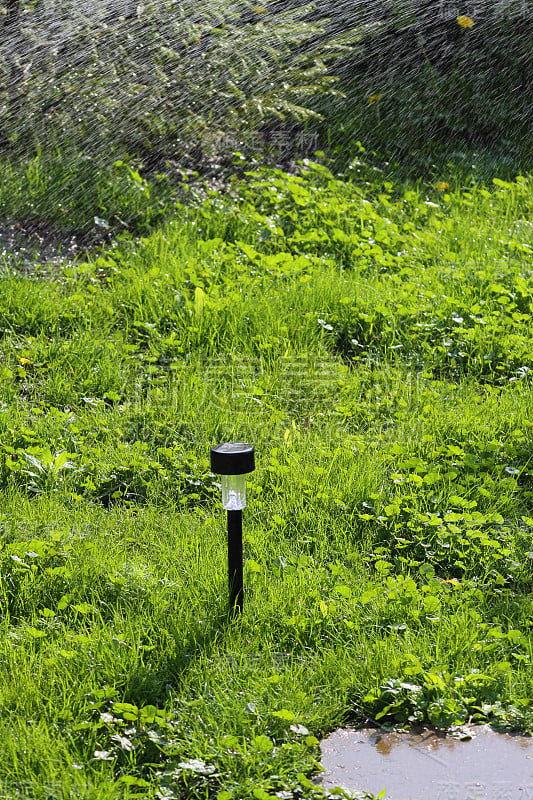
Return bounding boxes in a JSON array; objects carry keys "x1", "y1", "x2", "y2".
[{"x1": 310, "y1": 0, "x2": 533, "y2": 167}]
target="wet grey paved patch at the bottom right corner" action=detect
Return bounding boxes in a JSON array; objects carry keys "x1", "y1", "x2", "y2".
[{"x1": 321, "y1": 725, "x2": 533, "y2": 800}]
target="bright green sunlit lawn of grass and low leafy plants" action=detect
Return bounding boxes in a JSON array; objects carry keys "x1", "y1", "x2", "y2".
[{"x1": 0, "y1": 155, "x2": 533, "y2": 800}]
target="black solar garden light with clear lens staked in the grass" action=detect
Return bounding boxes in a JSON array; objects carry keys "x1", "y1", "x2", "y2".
[{"x1": 211, "y1": 442, "x2": 255, "y2": 611}]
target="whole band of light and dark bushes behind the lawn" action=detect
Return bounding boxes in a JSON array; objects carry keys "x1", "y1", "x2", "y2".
[{"x1": 0, "y1": 0, "x2": 533, "y2": 166}]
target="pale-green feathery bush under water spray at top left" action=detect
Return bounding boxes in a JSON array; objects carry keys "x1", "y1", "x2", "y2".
[{"x1": 0, "y1": 0, "x2": 358, "y2": 158}]
